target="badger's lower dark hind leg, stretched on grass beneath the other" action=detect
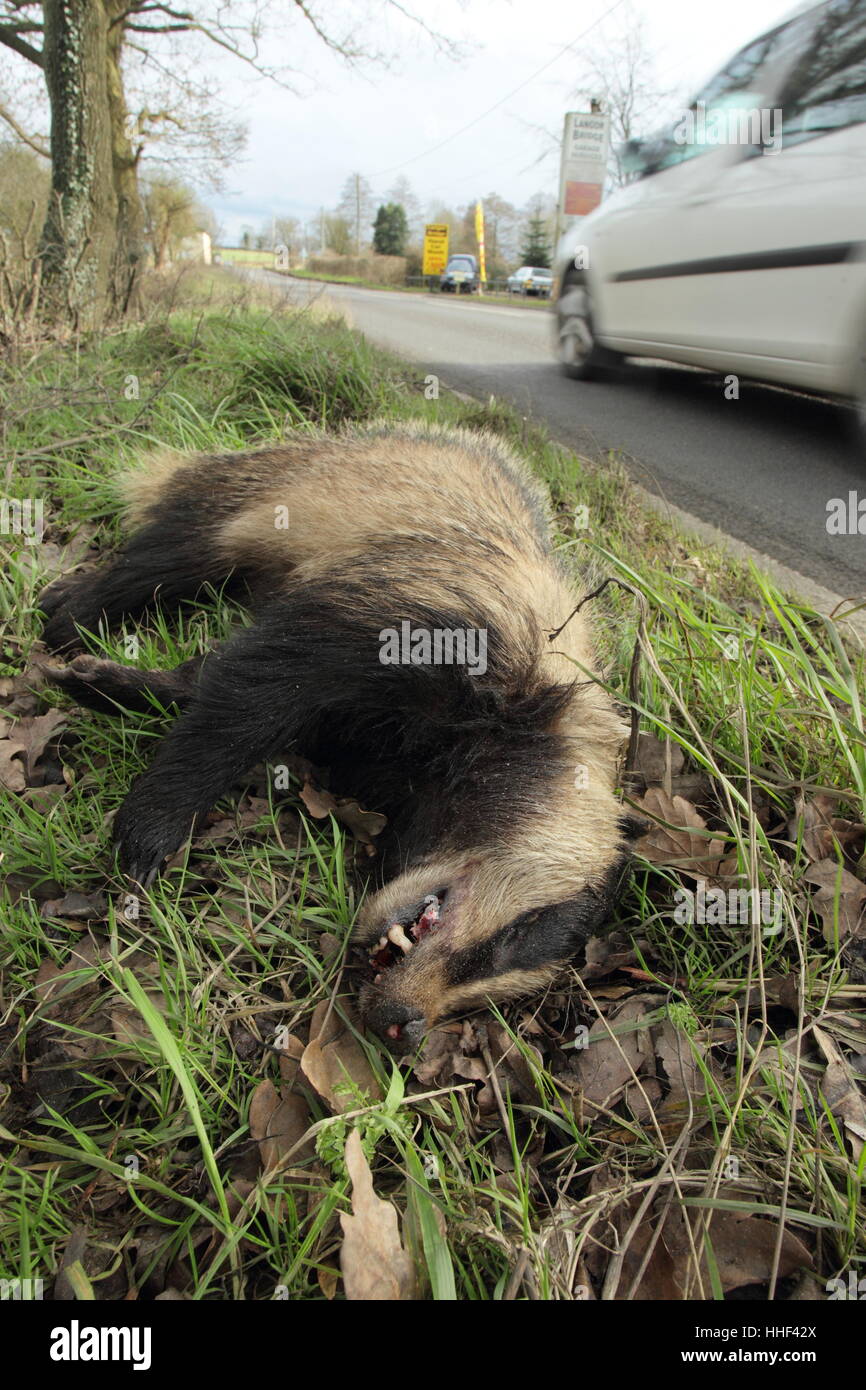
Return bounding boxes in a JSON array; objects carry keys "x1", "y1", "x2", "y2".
[{"x1": 42, "y1": 655, "x2": 204, "y2": 714}]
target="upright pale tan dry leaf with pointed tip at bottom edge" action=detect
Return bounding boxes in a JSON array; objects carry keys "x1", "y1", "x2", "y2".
[{"x1": 339, "y1": 1130, "x2": 416, "y2": 1302}]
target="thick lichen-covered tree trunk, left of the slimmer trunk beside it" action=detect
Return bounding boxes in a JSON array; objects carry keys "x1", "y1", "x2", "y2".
[{"x1": 40, "y1": 0, "x2": 117, "y2": 329}]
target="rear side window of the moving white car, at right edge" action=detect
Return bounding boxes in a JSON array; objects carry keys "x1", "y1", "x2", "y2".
[{"x1": 780, "y1": 0, "x2": 866, "y2": 149}]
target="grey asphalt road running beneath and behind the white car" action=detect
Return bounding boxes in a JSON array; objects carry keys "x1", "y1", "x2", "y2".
[{"x1": 247, "y1": 271, "x2": 866, "y2": 598}]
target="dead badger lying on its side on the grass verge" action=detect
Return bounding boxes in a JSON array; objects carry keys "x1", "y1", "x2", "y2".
[{"x1": 40, "y1": 425, "x2": 628, "y2": 1048}]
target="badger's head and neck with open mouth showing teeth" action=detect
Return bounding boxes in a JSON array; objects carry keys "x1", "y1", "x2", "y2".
[{"x1": 356, "y1": 706, "x2": 631, "y2": 1052}]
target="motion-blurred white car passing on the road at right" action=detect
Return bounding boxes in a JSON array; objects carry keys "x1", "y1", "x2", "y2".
[{"x1": 555, "y1": 0, "x2": 866, "y2": 417}]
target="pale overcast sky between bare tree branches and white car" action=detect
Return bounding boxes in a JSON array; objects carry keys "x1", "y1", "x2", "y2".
[{"x1": 206, "y1": 0, "x2": 794, "y2": 240}]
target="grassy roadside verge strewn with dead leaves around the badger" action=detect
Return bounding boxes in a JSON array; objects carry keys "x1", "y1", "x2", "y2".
[{"x1": 0, "y1": 272, "x2": 866, "y2": 1300}]
